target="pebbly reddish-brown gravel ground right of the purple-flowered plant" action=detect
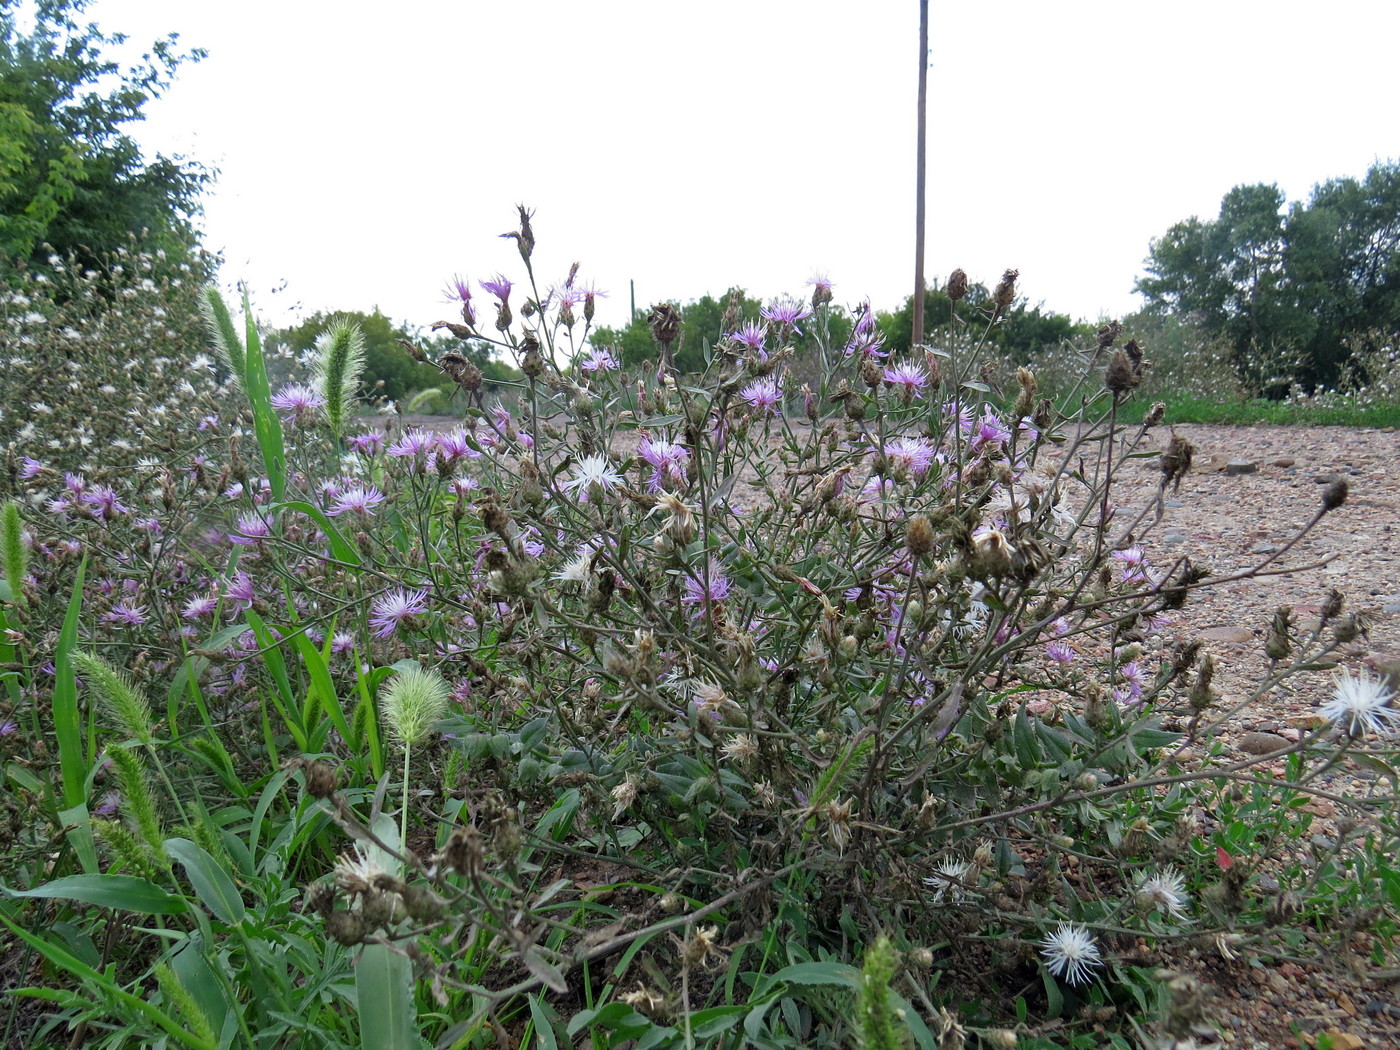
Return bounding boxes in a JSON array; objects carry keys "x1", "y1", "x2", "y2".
[{"x1": 1092, "y1": 426, "x2": 1400, "y2": 1050}]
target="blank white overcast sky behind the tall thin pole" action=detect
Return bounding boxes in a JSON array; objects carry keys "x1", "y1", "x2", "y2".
[{"x1": 88, "y1": 0, "x2": 1400, "y2": 337}]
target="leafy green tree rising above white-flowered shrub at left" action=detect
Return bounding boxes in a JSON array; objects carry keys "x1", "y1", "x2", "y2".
[{"x1": 0, "y1": 0, "x2": 211, "y2": 262}]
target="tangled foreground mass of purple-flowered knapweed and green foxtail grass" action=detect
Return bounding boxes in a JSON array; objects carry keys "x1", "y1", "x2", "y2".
[{"x1": 0, "y1": 209, "x2": 1400, "y2": 1047}]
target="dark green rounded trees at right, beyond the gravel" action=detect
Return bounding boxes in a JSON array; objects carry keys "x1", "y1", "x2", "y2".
[{"x1": 1137, "y1": 162, "x2": 1400, "y2": 396}]
